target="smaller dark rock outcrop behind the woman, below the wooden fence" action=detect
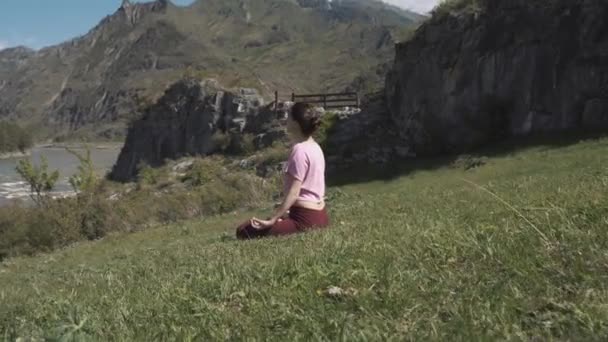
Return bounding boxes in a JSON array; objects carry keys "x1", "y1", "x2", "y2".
[{"x1": 110, "y1": 79, "x2": 285, "y2": 181}]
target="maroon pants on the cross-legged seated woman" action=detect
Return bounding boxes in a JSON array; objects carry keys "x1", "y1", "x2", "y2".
[{"x1": 236, "y1": 207, "x2": 329, "y2": 240}]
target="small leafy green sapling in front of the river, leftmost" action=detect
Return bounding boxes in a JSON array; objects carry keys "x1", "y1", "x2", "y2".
[{"x1": 15, "y1": 156, "x2": 59, "y2": 206}]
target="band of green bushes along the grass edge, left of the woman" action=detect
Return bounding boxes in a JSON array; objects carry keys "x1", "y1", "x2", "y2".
[{"x1": 0, "y1": 154, "x2": 280, "y2": 260}]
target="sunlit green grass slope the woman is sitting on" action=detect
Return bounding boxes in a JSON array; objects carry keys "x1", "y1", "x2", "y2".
[{"x1": 0, "y1": 139, "x2": 608, "y2": 341}]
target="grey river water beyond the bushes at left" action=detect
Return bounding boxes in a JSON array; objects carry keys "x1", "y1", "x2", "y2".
[{"x1": 0, "y1": 146, "x2": 120, "y2": 205}]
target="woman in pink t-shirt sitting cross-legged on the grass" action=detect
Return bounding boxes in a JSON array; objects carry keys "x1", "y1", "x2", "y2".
[{"x1": 236, "y1": 103, "x2": 329, "y2": 239}]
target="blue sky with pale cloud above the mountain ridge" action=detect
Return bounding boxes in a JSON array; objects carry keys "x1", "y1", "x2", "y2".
[{"x1": 0, "y1": 0, "x2": 437, "y2": 50}]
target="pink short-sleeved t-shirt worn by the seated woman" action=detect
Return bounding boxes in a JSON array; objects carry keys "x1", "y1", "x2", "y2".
[{"x1": 285, "y1": 140, "x2": 325, "y2": 202}]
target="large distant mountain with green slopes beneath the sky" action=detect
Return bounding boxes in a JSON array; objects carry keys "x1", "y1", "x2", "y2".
[{"x1": 0, "y1": 0, "x2": 420, "y2": 138}]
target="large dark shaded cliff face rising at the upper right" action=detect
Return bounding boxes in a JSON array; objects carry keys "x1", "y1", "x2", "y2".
[{"x1": 385, "y1": 0, "x2": 608, "y2": 154}]
